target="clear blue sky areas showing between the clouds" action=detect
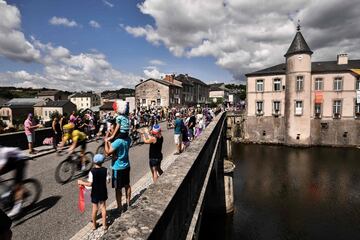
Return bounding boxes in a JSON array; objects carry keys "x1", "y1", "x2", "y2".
[{"x1": 0, "y1": 0, "x2": 232, "y2": 91}]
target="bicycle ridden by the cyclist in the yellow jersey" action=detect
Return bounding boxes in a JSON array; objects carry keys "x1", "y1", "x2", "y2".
[{"x1": 55, "y1": 151, "x2": 94, "y2": 184}]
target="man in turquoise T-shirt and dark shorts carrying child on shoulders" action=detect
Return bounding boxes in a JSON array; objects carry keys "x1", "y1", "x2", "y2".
[{"x1": 105, "y1": 137, "x2": 131, "y2": 211}]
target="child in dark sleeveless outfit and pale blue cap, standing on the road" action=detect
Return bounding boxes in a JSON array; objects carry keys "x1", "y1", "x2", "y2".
[{"x1": 78, "y1": 154, "x2": 110, "y2": 230}]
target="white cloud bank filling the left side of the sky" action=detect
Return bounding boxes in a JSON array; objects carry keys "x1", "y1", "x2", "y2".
[{"x1": 0, "y1": 0, "x2": 142, "y2": 91}]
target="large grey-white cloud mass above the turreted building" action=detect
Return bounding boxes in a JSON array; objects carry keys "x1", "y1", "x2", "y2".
[{"x1": 125, "y1": 0, "x2": 360, "y2": 79}]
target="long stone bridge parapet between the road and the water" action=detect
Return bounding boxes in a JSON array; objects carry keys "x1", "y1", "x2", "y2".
[{"x1": 102, "y1": 113, "x2": 226, "y2": 239}]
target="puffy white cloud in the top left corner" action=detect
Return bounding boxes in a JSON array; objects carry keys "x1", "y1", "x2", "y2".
[{"x1": 0, "y1": 0, "x2": 40, "y2": 62}]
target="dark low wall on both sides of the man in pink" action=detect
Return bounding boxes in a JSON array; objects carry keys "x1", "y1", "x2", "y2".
[{"x1": 0, "y1": 128, "x2": 53, "y2": 149}]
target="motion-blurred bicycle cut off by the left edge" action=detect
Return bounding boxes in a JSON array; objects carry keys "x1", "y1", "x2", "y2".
[{"x1": 0, "y1": 159, "x2": 42, "y2": 217}]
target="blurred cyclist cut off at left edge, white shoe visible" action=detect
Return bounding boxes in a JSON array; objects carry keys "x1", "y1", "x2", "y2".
[{"x1": 0, "y1": 147, "x2": 25, "y2": 217}]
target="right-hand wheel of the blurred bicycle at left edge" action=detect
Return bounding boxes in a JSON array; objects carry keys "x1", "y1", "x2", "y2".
[{"x1": 22, "y1": 178, "x2": 42, "y2": 209}]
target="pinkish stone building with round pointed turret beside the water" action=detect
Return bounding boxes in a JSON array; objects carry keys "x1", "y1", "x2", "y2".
[{"x1": 245, "y1": 27, "x2": 360, "y2": 146}]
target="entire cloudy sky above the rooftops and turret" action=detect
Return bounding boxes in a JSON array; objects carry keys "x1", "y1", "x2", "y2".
[{"x1": 0, "y1": 0, "x2": 360, "y2": 92}]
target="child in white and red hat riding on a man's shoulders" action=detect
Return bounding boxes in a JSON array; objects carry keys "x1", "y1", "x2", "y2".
[{"x1": 108, "y1": 101, "x2": 130, "y2": 141}]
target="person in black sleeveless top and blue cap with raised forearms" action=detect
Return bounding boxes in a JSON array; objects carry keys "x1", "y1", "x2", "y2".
[{"x1": 141, "y1": 124, "x2": 164, "y2": 182}]
